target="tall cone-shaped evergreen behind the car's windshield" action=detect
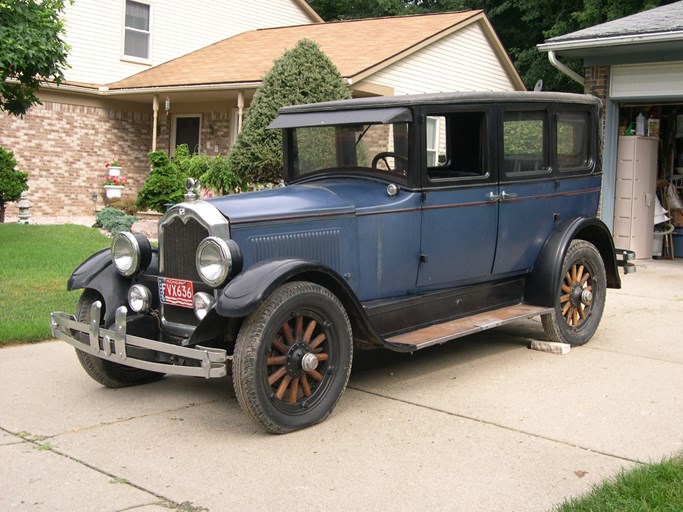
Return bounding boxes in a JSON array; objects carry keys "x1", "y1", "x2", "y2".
[{"x1": 228, "y1": 39, "x2": 351, "y2": 183}]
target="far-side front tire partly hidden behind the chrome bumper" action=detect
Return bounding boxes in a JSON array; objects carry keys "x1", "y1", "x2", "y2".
[{"x1": 76, "y1": 290, "x2": 164, "y2": 388}]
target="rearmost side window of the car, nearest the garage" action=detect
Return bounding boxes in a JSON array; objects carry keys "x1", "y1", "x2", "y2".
[{"x1": 557, "y1": 111, "x2": 591, "y2": 171}]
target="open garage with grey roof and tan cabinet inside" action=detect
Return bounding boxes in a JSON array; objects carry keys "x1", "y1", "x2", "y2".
[{"x1": 539, "y1": 1, "x2": 683, "y2": 259}]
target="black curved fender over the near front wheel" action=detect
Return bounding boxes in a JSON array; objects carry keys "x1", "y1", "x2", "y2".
[{"x1": 216, "y1": 259, "x2": 381, "y2": 344}]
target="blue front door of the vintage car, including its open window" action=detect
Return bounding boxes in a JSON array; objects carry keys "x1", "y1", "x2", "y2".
[{"x1": 417, "y1": 107, "x2": 498, "y2": 291}]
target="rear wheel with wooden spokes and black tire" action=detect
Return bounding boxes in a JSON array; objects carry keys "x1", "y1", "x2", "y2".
[{"x1": 541, "y1": 240, "x2": 607, "y2": 345}]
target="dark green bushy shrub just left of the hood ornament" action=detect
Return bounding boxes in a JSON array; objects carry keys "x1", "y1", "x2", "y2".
[{"x1": 135, "y1": 151, "x2": 185, "y2": 213}]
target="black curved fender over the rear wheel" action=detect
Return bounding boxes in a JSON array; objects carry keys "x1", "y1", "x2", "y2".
[{"x1": 524, "y1": 217, "x2": 621, "y2": 306}]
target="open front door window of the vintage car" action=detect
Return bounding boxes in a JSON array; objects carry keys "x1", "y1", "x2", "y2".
[{"x1": 425, "y1": 112, "x2": 488, "y2": 181}]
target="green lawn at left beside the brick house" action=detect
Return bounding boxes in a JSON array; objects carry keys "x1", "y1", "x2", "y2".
[{"x1": 0, "y1": 224, "x2": 110, "y2": 345}]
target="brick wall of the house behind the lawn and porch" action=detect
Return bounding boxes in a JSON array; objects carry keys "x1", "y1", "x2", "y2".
[{"x1": 0, "y1": 101, "x2": 230, "y2": 217}]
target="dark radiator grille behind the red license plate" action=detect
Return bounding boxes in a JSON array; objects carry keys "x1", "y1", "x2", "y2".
[{"x1": 159, "y1": 217, "x2": 209, "y2": 325}]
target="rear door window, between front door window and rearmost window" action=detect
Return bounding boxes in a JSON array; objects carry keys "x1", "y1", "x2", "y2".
[{"x1": 503, "y1": 110, "x2": 548, "y2": 176}]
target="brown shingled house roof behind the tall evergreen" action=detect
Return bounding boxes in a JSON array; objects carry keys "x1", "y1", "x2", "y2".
[{"x1": 109, "y1": 11, "x2": 482, "y2": 90}]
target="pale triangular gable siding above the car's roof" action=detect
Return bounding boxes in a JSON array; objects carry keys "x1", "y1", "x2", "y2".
[{"x1": 367, "y1": 24, "x2": 515, "y2": 95}]
